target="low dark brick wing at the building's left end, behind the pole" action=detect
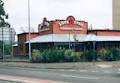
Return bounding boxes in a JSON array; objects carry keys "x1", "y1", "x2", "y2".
[{"x1": 13, "y1": 33, "x2": 38, "y2": 56}]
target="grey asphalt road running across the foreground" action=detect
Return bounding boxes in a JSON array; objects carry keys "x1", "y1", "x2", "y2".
[{"x1": 0, "y1": 65, "x2": 120, "y2": 83}]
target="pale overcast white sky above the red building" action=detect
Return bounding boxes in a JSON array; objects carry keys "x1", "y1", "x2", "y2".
[{"x1": 3, "y1": 0, "x2": 112, "y2": 34}]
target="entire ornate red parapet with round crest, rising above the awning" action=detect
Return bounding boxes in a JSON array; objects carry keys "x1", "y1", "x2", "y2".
[{"x1": 38, "y1": 16, "x2": 88, "y2": 35}]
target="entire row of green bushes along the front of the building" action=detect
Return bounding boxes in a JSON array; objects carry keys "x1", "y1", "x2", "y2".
[{"x1": 31, "y1": 48, "x2": 120, "y2": 63}]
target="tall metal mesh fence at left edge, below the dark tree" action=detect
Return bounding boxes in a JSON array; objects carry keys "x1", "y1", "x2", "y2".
[{"x1": 0, "y1": 27, "x2": 16, "y2": 60}]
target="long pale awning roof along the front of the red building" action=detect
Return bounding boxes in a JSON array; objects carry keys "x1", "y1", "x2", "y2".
[{"x1": 25, "y1": 34, "x2": 120, "y2": 43}]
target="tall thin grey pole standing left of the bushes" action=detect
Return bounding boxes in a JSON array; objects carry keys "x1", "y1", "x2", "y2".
[{"x1": 28, "y1": 0, "x2": 32, "y2": 60}]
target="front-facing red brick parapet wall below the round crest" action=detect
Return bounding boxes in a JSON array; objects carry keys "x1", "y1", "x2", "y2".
[{"x1": 53, "y1": 21, "x2": 88, "y2": 34}]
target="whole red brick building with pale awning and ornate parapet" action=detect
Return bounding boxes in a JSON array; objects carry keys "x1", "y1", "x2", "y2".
[{"x1": 14, "y1": 16, "x2": 120, "y2": 55}]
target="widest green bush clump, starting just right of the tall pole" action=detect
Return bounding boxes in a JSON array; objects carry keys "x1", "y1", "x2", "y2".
[{"x1": 31, "y1": 48, "x2": 80, "y2": 63}]
